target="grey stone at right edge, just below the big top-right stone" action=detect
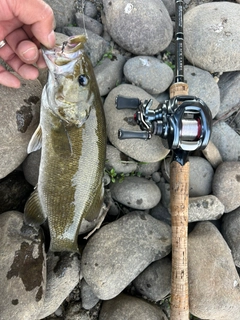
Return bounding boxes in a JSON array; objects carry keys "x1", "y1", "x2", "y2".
[{"x1": 216, "y1": 71, "x2": 240, "y2": 119}]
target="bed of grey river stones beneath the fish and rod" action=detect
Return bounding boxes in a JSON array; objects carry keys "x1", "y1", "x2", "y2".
[{"x1": 0, "y1": 0, "x2": 240, "y2": 320}]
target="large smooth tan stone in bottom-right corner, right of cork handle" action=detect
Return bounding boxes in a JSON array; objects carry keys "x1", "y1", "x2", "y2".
[{"x1": 188, "y1": 222, "x2": 240, "y2": 320}]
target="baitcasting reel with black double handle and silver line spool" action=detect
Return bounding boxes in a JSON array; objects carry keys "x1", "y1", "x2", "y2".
[{"x1": 116, "y1": 96, "x2": 212, "y2": 151}]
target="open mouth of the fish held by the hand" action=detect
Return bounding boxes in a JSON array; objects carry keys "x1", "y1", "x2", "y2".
[{"x1": 43, "y1": 35, "x2": 87, "y2": 66}]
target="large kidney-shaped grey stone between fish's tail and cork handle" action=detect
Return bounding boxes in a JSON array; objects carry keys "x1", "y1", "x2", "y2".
[{"x1": 81, "y1": 211, "x2": 171, "y2": 300}]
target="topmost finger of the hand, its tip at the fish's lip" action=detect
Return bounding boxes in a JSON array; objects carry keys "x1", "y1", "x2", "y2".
[{"x1": 16, "y1": 0, "x2": 55, "y2": 48}]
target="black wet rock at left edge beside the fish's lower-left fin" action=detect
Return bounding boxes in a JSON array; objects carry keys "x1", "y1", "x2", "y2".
[{"x1": 0, "y1": 171, "x2": 33, "y2": 213}]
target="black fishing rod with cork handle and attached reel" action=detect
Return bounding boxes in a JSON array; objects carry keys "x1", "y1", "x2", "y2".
[{"x1": 116, "y1": 0, "x2": 212, "y2": 320}]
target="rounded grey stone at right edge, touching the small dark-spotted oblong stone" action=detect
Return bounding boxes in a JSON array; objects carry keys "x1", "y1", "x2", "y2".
[{"x1": 212, "y1": 161, "x2": 240, "y2": 212}]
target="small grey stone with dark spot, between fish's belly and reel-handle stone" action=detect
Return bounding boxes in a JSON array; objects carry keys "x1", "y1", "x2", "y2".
[{"x1": 105, "y1": 145, "x2": 138, "y2": 174}]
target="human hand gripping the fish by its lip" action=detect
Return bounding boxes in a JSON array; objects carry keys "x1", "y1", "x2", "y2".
[{"x1": 0, "y1": 0, "x2": 55, "y2": 88}]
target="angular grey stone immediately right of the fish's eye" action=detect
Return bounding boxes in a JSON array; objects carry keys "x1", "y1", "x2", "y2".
[{"x1": 94, "y1": 54, "x2": 126, "y2": 96}]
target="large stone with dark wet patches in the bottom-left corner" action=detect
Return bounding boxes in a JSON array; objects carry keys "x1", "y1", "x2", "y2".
[{"x1": 0, "y1": 211, "x2": 46, "y2": 320}]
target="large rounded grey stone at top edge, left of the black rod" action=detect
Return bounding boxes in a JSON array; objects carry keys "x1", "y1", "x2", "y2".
[{"x1": 103, "y1": 0, "x2": 173, "y2": 55}]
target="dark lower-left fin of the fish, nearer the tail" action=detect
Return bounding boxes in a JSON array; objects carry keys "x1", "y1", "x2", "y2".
[{"x1": 24, "y1": 189, "x2": 47, "y2": 227}]
